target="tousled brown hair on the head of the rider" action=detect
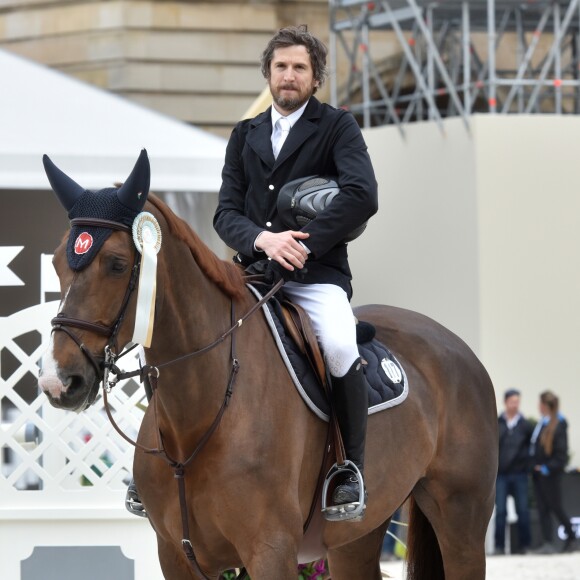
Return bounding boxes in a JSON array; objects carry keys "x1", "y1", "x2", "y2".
[{"x1": 260, "y1": 24, "x2": 328, "y2": 92}]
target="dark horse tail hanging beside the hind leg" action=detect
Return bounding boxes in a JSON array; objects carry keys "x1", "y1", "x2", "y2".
[{"x1": 407, "y1": 496, "x2": 445, "y2": 580}]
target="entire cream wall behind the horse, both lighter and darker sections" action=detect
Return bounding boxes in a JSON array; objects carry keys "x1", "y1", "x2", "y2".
[{"x1": 349, "y1": 115, "x2": 580, "y2": 465}]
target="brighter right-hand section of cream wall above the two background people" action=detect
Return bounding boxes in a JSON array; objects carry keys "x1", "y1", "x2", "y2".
[{"x1": 475, "y1": 116, "x2": 580, "y2": 466}]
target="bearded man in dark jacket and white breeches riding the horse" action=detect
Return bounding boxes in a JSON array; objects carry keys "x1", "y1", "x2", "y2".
[{"x1": 214, "y1": 26, "x2": 378, "y2": 505}]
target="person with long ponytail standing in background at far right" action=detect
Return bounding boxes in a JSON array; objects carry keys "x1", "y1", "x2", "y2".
[{"x1": 530, "y1": 391, "x2": 577, "y2": 554}]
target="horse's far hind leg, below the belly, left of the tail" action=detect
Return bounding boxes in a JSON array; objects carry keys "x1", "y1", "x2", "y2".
[{"x1": 328, "y1": 518, "x2": 390, "y2": 580}]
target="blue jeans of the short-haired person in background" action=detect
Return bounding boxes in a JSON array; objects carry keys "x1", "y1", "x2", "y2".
[{"x1": 495, "y1": 473, "x2": 531, "y2": 550}]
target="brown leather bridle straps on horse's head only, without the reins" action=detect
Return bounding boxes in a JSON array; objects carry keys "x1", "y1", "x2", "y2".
[{"x1": 51, "y1": 218, "x2": 140, "y2": 382}]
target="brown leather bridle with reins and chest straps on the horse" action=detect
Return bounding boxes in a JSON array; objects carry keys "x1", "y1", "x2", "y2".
[{"x1": 51, "y1": 218, "x2": 284, "y2": 580}]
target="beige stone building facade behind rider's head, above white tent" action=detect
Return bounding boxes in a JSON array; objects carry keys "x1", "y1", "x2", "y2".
[{"x1": 0, "y1": 0, "x2": 329, "y2": 136}]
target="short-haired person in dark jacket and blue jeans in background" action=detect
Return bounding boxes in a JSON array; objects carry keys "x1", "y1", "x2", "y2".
[{"x1": 495, "y1": 389, "x2": 533, "y2": 555}]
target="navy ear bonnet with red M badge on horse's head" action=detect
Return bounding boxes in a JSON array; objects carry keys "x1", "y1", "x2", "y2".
[{"x1": 42, "y1": 149, "x2": 151, "y2": 271}]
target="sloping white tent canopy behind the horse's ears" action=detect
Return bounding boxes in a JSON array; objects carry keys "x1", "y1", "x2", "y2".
[{"x1": 0, "y1": 50, "x2": 226, "y2": 192}]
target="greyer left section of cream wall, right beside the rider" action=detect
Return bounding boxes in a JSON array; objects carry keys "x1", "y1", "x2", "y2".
[{"x1": 349, "y1": 119, "x2": 480, "y2": 350}]
